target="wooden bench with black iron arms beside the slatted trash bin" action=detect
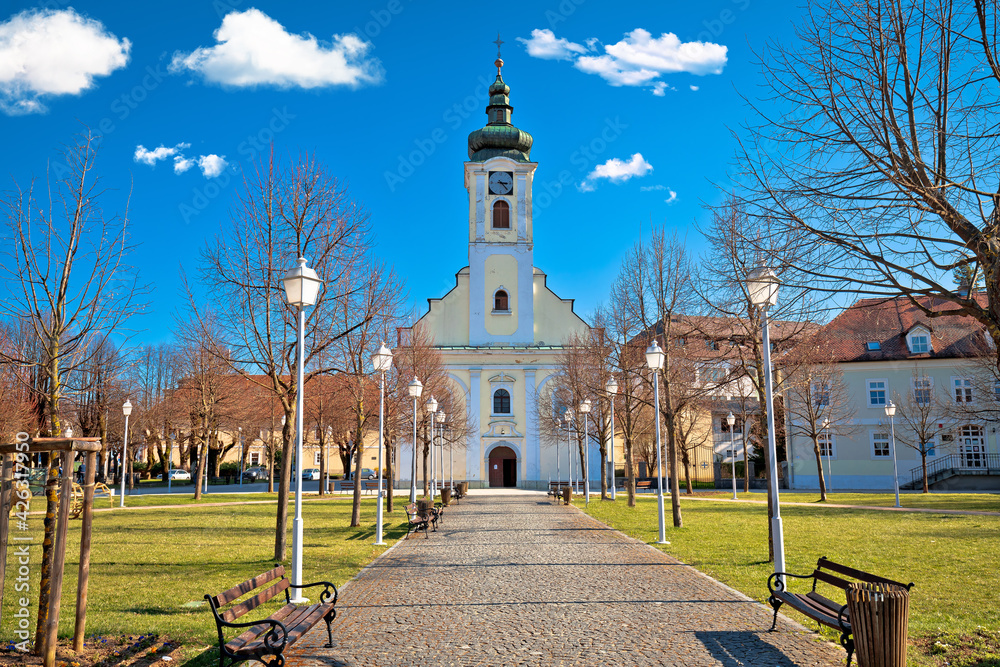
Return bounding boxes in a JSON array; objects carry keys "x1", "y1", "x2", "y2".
[{"x1": 767, "y1": 556, "x2": 913, "y2": 667}]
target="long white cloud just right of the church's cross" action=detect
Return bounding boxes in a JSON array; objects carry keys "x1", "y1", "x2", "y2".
[{"x1": 518, "y1": 28, "x2": 728, "y2": 97}]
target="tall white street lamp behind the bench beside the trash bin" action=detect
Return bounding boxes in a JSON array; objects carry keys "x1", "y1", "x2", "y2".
[{"x1": 747, "y1": 265, "x2": 785, "y2": 585}]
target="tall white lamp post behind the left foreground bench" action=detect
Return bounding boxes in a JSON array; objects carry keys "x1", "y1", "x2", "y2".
[{"x1": 282, "y1": 257, "x2": 323, "y2": 604}]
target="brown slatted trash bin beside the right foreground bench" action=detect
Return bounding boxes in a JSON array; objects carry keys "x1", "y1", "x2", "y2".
[{"x1": 847, "y1": 583, "x2": 910, "y2": 667}]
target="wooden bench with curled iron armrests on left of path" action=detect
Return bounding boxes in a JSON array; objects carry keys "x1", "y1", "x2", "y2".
[{"x1": 205, "y1": 565, "x2": 338, "y2": 667}]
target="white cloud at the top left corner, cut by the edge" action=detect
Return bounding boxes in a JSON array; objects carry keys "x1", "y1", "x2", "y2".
[{"x1": 0, "y1": 9, "x2": 132, "y2": 115}]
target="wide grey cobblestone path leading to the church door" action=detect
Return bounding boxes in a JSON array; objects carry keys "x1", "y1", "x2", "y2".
[{"x1": 287, "y1": 493, "x2": 846, "y2": 667}]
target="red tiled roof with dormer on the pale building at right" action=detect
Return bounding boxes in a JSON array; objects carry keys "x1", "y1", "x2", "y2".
[{"x1": 814, "y1": 295, "x2": 992, "y2": 362}]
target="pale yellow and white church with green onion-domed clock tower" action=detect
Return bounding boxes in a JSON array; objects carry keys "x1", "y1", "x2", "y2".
[{"x1": 401, "y1": 54, "x2": 600, "y2": 489}]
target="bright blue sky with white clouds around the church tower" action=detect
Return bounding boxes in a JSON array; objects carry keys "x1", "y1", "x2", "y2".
[{"x1": 0, "y1": 0, "x2": 801, "y2": 342}]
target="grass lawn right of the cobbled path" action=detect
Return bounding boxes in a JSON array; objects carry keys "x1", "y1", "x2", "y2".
[{"x1": 575, "y1": 494, "x2": 1000, "y2": 665}]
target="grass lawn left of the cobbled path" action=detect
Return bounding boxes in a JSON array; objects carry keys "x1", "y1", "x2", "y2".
[{"x1": 2, "y1": 494, "x2": 406, "y2": 667}]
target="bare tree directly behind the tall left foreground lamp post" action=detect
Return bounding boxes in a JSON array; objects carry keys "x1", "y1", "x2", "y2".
[{"x1": 192, "y1": 153, "x2": 370, "y2": 560}]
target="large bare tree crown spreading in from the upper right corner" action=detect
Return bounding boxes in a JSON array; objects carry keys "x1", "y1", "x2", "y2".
[{"x1": 738, "y1": 0, "x2": 1000, "y2": 362}]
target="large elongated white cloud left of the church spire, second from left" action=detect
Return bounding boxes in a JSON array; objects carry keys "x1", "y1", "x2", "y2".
[{"x1": 170, "y1": 8, "x2": 382, "y2": 88}]
